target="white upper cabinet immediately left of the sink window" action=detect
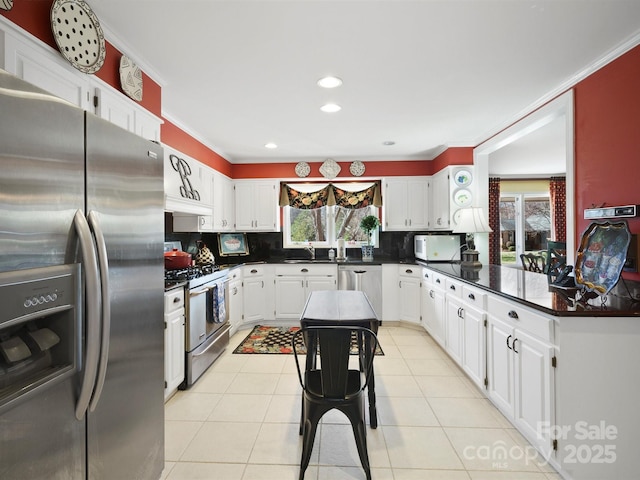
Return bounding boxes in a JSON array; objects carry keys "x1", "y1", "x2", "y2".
[{"x1": 234, "y1": 180, "x2": 280, "y2": 232}]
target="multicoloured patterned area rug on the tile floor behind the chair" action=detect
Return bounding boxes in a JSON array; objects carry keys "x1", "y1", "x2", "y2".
[{"x1": 233, "y1": 325, "x2": 384, "y2": 355}]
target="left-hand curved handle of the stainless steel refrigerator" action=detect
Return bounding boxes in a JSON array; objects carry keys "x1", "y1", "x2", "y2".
[{"x1": 73, "y1": 210, "x2": 100, "y2": 420}]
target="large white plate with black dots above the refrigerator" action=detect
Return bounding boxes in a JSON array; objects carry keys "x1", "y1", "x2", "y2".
[{"x1": 51, "y1": 0, "x2": 106, "y2": 73}]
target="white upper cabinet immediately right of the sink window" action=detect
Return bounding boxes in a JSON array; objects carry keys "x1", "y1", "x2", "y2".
[{"x1": 382, "y1": 177, "x2": 430, "y2": 231}]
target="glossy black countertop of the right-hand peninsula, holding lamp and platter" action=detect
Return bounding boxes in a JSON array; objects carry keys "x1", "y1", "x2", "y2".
[{"x1": 418, "y1": 262, "x2": 640, "y2": 317}]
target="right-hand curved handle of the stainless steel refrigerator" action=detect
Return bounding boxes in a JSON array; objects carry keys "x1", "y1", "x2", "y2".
[{"x1": 88, "y1": 211, "x2": 111, "y2": 412}]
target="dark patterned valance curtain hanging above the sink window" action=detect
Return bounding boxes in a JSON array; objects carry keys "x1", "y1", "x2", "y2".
[{"x1": 280, "y1": 182, "x2": 382, "y2": 210}]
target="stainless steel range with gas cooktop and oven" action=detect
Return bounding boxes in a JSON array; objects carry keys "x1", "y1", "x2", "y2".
[{"x1": 165, "y1": 266, "x2": 230, "y2": 390}]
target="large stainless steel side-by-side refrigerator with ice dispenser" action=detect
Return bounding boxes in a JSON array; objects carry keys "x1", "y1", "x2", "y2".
[{"x1": 0, "y1": 70, "x2": 164, "y2": 480}]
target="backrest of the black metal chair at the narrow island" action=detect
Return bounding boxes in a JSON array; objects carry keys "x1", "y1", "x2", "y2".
[{"x1": 291, "y1": 326, "x2": 378, "y2": 399}]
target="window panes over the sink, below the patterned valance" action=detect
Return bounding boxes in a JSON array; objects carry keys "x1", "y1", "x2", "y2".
[{"x1": 283, "y1": 206, "x2": 378, "y2": 248}]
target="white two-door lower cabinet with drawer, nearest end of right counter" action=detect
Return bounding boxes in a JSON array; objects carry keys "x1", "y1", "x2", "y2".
[{"x1": 487, "y1": 297, "x2": 554, "y2": 455}]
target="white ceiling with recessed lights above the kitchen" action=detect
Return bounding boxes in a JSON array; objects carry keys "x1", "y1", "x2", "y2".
[{"x1": 88, "y1": 0, "x2": 640, "y2": 163}]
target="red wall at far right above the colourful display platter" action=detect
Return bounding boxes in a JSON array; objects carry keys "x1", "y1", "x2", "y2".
[{"x1": 575, "y1": 46, "x2": 640, "y2": 280}]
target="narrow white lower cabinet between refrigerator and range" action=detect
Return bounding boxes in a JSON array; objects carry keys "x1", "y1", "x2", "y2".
[{"x1": 164, "y1": 288, "x2": 185, "y2": 400}]
